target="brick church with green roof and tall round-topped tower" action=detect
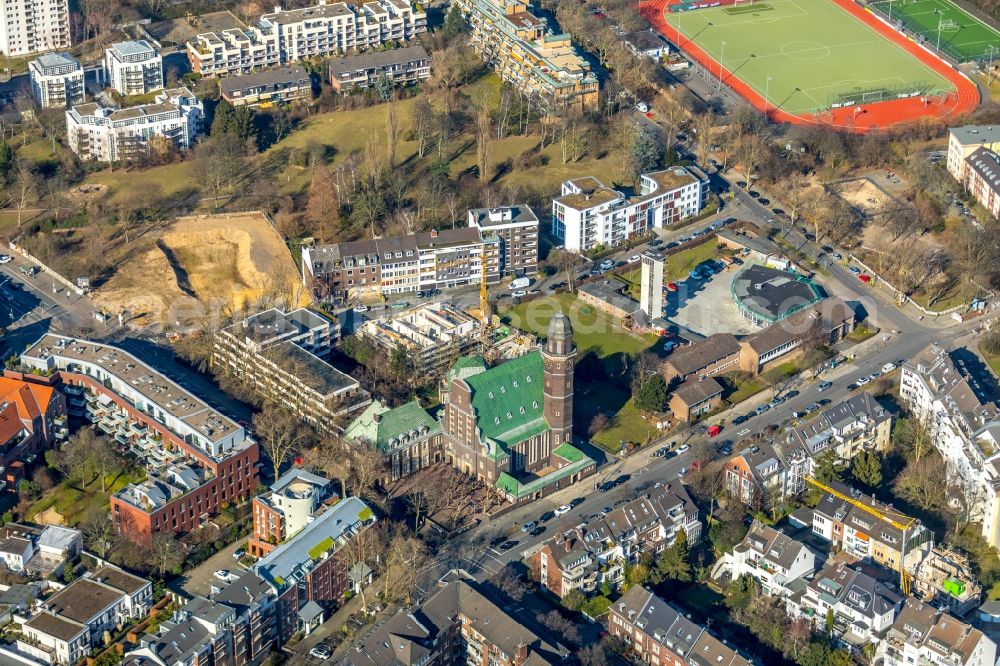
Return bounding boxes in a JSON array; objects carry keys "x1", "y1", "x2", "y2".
[{"x1": 344, "y1": 313, "x2": 596, "y2": 502}]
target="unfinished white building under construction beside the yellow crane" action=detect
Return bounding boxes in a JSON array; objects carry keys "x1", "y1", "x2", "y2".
[{"x1": 358, "y1": 303, "x2": 482, "y2": 377}]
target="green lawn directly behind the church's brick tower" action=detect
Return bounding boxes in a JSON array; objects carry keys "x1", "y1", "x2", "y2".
[{"x1": 504, "y1": 294, "x2": 659, "y2": 358}]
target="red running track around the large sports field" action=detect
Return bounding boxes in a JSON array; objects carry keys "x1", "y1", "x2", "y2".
[{"x1": 639, "y1": 0, "x2": 979, "y2": 134}]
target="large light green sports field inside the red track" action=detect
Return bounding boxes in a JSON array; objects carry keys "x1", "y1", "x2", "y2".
[{"x1": 665, "y1": 0, "x2": 954, "y2": 114}]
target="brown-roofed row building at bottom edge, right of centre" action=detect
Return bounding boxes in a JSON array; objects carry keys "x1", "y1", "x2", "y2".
[{"x1": 608, "y1": 585, "x2": 753, "y2": 666}]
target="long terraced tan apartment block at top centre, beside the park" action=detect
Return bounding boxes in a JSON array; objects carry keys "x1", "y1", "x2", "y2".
[{"x1": 458, "y1": 0, "x2": 600, "y2": 109}]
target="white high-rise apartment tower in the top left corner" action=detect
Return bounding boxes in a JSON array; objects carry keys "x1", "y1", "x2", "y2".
[{"x1": 0, "y1": 0, "x2": 73, "y2": 57}]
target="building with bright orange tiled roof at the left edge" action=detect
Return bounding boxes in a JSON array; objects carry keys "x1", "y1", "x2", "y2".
[{"x1": 0, "y1": 373, "x2": 69, "y2": 492}]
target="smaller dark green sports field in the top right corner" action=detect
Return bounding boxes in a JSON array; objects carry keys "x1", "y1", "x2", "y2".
[{"x1": 871, "y1": 0, "x2": 1000, "y2": 62}]
